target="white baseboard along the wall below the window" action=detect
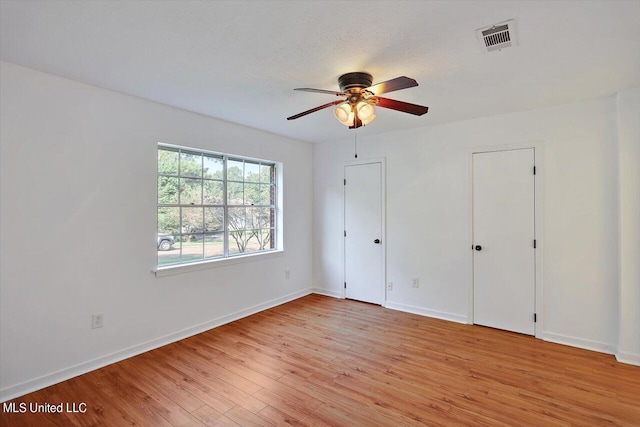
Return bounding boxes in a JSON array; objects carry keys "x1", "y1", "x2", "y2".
[{"x1": 0, "y1": 288, "x2": 313, "y2": 403}]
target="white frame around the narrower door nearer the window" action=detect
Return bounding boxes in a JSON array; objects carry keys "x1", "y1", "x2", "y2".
[{"x1": 342, "y1": 157, "x2": 387, "y2": 307}]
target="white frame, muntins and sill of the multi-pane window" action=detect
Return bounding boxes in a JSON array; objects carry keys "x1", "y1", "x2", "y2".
[{"x1": 152, "y1": 142, "x2": 284, "y2": 277}]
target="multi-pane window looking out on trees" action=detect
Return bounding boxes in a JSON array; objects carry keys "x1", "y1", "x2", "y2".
[{"x1": 158, "y1": 144, "x2": 277, "y2": 267}]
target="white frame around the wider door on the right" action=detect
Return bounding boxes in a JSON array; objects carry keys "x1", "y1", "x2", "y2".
[{"x1": 467, "y1": 141, "x2": 545, "y2": 339}]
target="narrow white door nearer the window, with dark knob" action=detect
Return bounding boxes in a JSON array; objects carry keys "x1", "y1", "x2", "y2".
[{"x1": 344, "y1": 163, "x2": 384, "y2": 304}]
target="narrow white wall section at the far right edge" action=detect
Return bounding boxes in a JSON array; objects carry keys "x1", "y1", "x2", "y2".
[{"x1": 616, "y1": 88, "x2": 640, "y2": 365}]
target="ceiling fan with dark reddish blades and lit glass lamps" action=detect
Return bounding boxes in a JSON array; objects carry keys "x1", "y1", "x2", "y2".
[{"x1": 287, "y1": 72, "x2": 429, "y2": 129}]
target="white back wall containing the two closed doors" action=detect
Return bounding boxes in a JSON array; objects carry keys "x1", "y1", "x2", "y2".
[{"x1": 314, "y1": 97, "x2": 618, "y2": 353}]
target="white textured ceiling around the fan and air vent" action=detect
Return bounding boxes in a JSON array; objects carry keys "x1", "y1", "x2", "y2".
[{"x1": 0, "y1": 0, "x2": 640, "y2": 142}]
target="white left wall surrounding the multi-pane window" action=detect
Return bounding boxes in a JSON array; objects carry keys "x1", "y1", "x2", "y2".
[{"x1": 0, "y1": 63, "x2": 312, "y2": 400}]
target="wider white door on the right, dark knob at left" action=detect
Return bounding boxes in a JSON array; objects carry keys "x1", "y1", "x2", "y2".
[{"x1": 473, "y1": 148, "x2": 535, "y2": 335}]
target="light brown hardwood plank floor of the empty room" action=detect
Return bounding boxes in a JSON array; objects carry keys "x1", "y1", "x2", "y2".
[{"x1": 0, "y1": 295, "x2": 640, "y2": 426}]
